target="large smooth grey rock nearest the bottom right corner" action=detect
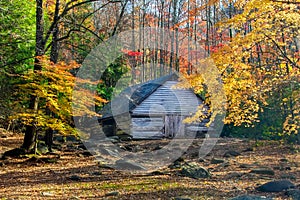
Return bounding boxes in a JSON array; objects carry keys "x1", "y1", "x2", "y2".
[{"x1": 256, "y1": 180, "x2": 295, "y2": 192}]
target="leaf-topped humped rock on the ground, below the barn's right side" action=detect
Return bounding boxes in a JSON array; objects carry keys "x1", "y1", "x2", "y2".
[{"x1": 181, "y1": 162, "x2": 211, "y2": 179}]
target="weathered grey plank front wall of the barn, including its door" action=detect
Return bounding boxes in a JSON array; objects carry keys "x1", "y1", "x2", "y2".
[{"x1": 131, "y1": 81, "x2": 205, "y2": 138}]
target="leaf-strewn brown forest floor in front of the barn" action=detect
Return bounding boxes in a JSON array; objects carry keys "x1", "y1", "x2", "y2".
[{"x1": 0, "y1": 128, "x2": 300, "y2": 200}]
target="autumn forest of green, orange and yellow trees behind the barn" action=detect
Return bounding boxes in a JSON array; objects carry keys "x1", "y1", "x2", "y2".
[{"x1": 0, "y1": 0, "x2": 300, "y2": 151}]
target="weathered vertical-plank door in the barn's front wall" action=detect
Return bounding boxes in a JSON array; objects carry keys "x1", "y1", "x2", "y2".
[{"x1": 164, "y1": 115, "x2": 184, "y2": 138}]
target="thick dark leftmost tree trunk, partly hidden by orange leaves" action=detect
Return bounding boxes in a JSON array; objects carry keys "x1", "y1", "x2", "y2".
[{"x1": 22, "y1": 0, "x2": 45, "y2": 152}]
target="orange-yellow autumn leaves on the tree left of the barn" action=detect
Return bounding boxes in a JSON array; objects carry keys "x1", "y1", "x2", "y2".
[{"x1": 12, "y1": 57, "x2": 106, "y2": 134}]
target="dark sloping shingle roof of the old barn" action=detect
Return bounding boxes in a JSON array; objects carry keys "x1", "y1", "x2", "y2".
[{"x1": 100, "y1": 73, "x2": 202, "y2": 120}]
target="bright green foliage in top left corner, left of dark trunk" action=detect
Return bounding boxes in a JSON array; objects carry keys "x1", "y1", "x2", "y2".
[{"x1": 0, "y1": 0, "x2": 35, "y2": 71}]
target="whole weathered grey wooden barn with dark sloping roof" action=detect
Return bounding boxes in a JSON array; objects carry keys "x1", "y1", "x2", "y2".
[{"x1": 99, "y1": 73, "x2": 207, "y2": 139}]
